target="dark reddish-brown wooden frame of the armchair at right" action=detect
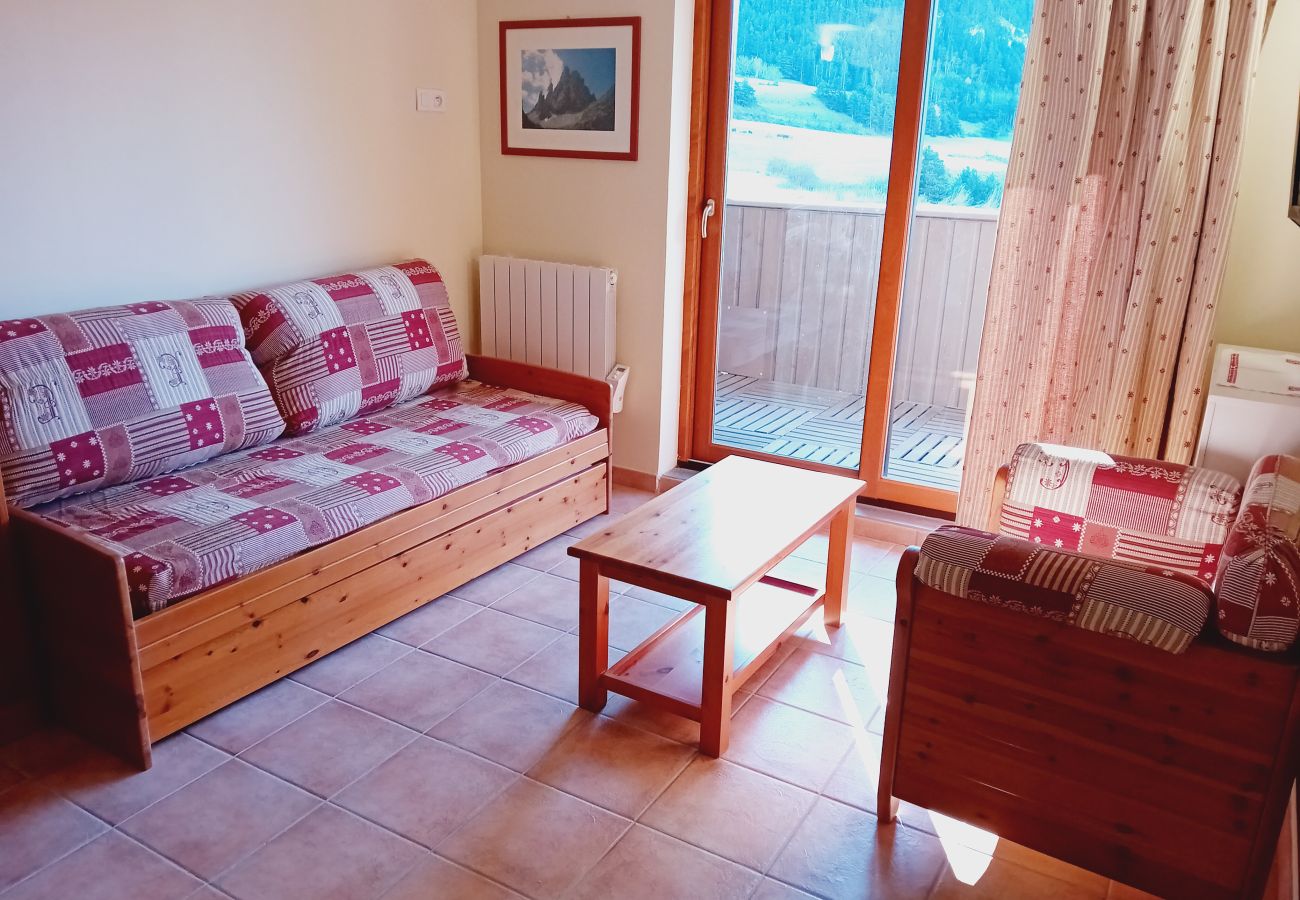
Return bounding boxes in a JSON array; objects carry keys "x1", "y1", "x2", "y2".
[{"x1": 878, "y1": 468, "x2": 1300, "y2": 897}]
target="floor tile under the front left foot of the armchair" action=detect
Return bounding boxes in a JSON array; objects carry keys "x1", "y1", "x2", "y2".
[{"x1": 768, "y1": 797, "x2": 944, "y2": 900}]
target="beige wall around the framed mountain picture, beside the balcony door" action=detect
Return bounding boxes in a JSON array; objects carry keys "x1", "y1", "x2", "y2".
[{"x1": 478, "y1": 0, "x2": 693, "y2": 473}]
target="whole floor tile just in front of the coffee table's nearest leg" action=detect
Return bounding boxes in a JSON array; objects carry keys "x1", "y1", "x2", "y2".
[{"x1": 640, "y1": 757, "x2": 816, "y2": 871}]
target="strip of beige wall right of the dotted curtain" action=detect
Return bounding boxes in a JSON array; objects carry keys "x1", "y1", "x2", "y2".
[{"x1": 1214, "y1": 0, "x2": 1300, "y2": 350}]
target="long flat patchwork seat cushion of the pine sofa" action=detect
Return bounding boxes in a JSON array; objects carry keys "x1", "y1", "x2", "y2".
[{"x1": 35, "y1": 381, "x2": 597, "y2": 616}]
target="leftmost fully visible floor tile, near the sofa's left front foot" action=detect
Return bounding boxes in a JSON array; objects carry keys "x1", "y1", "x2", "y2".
[{"x1": 120, "y1": 760, "x2": 320, "y2": 879}]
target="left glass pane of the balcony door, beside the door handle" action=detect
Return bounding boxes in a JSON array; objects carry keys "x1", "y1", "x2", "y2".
[{"x1": 712, "y1": 0, "x2": 904, "y2": 470}]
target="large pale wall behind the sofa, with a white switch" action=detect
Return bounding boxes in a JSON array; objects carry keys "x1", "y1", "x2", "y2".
[{"x1": 0, "y1": 0, "x2": 482, "y2": 329}]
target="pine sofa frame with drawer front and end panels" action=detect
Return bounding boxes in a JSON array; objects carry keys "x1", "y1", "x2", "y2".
[{"x1": 0, "y1": 356, "x2": 612, "y2": 769}]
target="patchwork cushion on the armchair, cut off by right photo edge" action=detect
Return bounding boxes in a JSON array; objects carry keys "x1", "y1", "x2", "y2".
[{"x1": 1216, "y1": 455, "x2": 1300, "y2": 650}]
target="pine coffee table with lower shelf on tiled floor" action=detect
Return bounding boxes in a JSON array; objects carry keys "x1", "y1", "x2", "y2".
[{"x1": 569, "y1": 457, "x2": 863, "y2": 757}]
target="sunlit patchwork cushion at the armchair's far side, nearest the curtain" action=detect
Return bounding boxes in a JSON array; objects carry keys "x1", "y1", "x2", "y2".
[{"x1": 998, "y1": 443, "x2": 1242, "y2": 584}]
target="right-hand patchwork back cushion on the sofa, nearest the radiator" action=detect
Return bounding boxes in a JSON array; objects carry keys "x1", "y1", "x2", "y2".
[{"x1": 230, "y1": 259, "x2": 465, "y2": 434}]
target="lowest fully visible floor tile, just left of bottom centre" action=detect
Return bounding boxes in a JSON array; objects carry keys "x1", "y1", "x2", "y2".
[{"x1": 438, "y1": 778, "x2": 631, "y2": 900}]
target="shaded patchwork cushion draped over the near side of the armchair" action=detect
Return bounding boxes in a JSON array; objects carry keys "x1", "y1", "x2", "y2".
[{"x1": 917, "y1": 525, "x2": 1214, "y2": 653}]
